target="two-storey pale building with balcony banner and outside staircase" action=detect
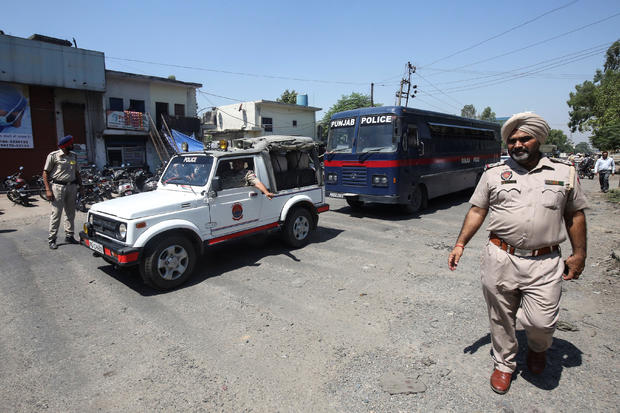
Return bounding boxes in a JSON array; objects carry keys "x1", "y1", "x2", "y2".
[{"x1": 100, "y1": 70, "x2": 202, "y2": 171}]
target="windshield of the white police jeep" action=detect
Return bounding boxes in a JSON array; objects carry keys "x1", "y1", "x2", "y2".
[{"x1": 161, "y1": 155, "x2": 213, "y2": 186}]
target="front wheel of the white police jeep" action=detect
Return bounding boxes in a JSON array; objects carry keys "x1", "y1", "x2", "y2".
[{"x1": 141, "y1": 236, "x2": 196, "y2": 290}]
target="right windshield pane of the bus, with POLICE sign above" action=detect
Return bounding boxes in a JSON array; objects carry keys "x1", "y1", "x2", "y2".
[{"x1": 355, "y1": 114, "x2": 398, "y2": 153}]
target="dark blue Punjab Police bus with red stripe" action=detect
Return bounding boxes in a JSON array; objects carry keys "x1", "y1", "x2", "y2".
[{"x1": 324, "y1": 106, "x2": 501, "y2": 213}]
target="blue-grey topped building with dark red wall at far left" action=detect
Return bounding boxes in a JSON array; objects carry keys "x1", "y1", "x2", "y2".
[{"x1": 0, "y1": 33, "x2": 106, "y2": 178}]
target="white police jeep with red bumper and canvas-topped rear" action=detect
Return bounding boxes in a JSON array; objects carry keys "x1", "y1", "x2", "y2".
[{"x1": 80, "y1": 136, "x2": 329, "y2": 290}]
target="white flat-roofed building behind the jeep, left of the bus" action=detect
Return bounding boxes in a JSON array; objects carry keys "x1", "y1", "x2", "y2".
[{"x1": 203, "y1": 100, "x2": 321, "y2": 140}]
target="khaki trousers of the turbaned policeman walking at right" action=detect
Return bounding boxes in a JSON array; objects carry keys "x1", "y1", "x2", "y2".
[{"x1": 480, "y1": 242, "x2": 564, "y2": 373}]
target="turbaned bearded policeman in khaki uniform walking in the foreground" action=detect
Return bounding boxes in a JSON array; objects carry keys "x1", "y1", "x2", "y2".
[{"x1": 448, "y1": 113, "x2": 586, "y2": 394}]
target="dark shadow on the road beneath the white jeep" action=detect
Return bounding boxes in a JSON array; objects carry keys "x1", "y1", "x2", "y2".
[{"x1": 94, "y1": 225, "x2": 343, "y2": 297}]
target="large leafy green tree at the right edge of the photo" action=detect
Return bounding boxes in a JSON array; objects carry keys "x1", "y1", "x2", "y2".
[{"x1": 566, "y1": 40, "x2": 620, "y2": 150}]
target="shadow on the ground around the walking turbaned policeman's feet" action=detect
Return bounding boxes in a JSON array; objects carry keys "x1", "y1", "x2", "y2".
[{"x1": 463, "y1": 330, "x2": 583, "y2": 390}]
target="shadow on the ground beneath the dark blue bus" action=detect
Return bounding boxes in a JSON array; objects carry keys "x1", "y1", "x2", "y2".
[{"x1": 330, "y1": 188, "x2": 473, "y2": 221}]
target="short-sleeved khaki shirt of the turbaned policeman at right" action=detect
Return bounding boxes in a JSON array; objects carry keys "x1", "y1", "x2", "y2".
[{"x1": 469, "y1": 157, "x2": 587, "y2": 249}]
